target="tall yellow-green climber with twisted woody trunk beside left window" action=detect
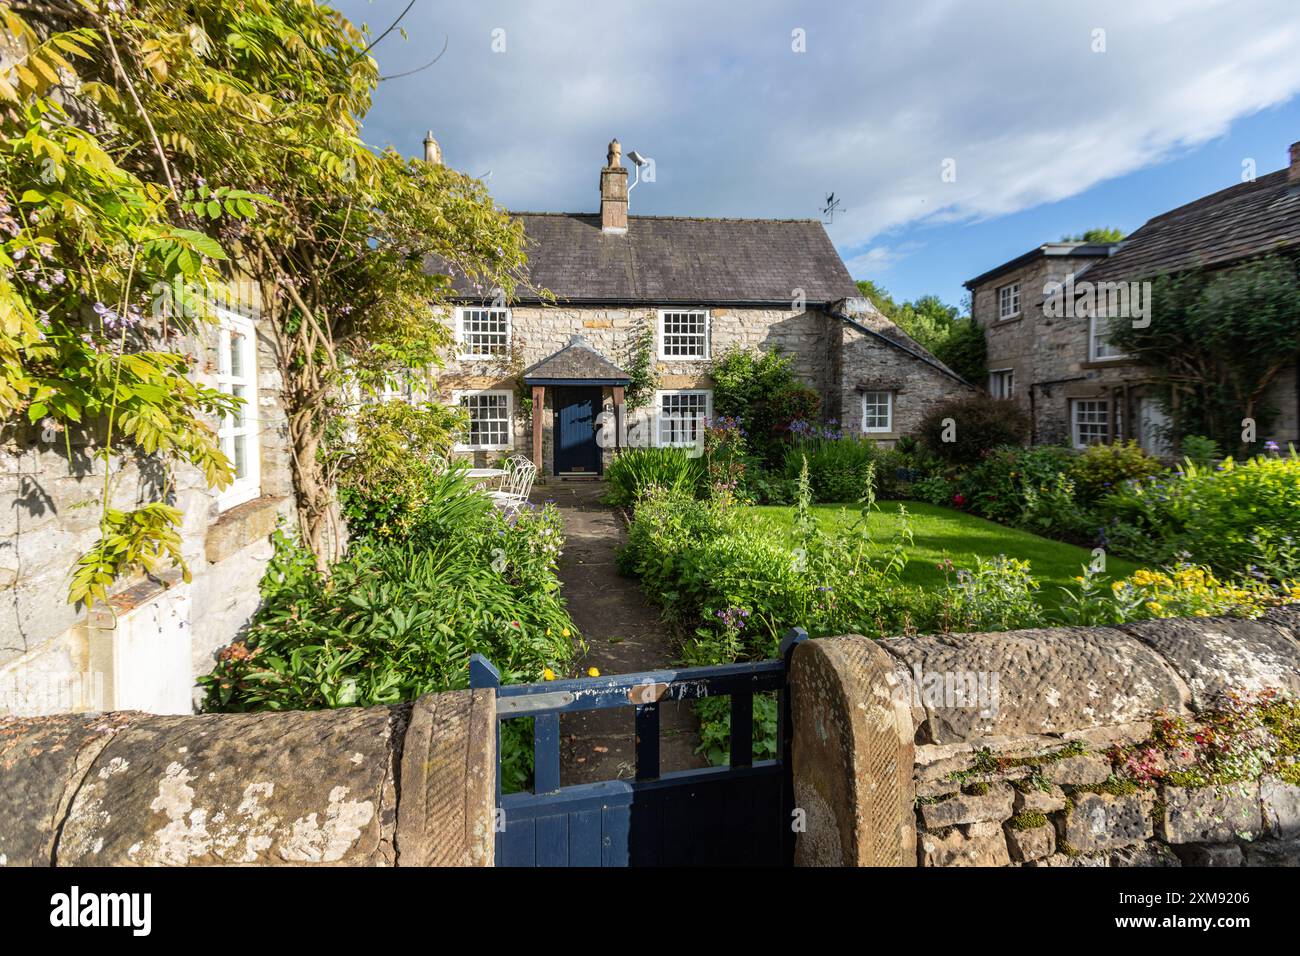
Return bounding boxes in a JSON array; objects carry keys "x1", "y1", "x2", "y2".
[{"x1": 8, "y1": 0, "x2": 524, "y2": 582}]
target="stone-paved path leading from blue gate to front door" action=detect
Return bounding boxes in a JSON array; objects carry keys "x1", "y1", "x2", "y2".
[{"x1": 530, "y1": 480, "x2": 707, "y2": 786}]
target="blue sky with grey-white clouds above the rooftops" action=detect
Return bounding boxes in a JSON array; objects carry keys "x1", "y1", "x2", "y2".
[{"x1": 335, "y1": 0, "x2": 1300, "y2": 303}]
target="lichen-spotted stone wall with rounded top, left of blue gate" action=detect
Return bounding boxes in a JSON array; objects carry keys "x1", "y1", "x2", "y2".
[{"x1": 0, "y1": 691, "x2": 497, "y2": 866}]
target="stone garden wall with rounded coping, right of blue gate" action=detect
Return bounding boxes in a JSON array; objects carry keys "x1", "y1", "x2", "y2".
[{"x1": 790, "y1": 607, "x2": 1300, "y2": 866}]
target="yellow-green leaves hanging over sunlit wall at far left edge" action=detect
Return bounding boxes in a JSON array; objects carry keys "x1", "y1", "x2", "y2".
[{"x1": 0, "y1": 3, "x2": 269, "y2": 605}]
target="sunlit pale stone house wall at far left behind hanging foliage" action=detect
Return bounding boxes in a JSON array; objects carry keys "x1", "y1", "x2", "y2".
[{"x1": 0, "y1": 283, "x2": 294, "y2": 715}]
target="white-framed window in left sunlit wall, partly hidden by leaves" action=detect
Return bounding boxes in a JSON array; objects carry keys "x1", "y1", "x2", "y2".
[{"x1": 217, "y1": 310, "x2": 261, "y2": 511}]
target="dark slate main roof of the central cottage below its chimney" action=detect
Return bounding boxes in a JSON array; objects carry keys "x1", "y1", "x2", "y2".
[{"x1": 441, "y1": 212, "x2": 858, "y2": 306}]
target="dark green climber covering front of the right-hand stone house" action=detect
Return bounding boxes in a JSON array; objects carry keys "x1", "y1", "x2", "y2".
[{"x1": 1110, "y1": 255, "x2": 1300, "y2": 451}]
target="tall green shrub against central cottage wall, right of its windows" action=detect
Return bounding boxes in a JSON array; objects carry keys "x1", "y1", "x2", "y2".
[{"x1": 711, "y1": 347, "x2": 822, "y2": 468}]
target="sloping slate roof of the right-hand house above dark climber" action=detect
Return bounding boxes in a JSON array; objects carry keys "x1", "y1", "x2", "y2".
[{"x1": 1079, "y1": 169, "x2": 1300, "y2": 282}]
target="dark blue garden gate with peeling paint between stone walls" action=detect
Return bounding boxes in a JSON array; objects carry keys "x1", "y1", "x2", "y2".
[{"x1": 469, "y1": 628, "x2": 807, "y2": 866}]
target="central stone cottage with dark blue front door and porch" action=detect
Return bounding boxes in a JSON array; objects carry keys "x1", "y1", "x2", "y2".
[{"x1": 436, "y1": 137, "x2": 971, "y2": 477}]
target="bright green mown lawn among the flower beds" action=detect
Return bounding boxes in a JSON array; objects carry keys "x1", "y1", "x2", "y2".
[{"x1": 754, "y1": 501, "x2": 1140, "y2": 607}]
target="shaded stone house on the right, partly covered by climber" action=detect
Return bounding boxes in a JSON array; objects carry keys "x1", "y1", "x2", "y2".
[{"x1": 966, "y1": 143, "x2": 1300, "y2": 455}]
